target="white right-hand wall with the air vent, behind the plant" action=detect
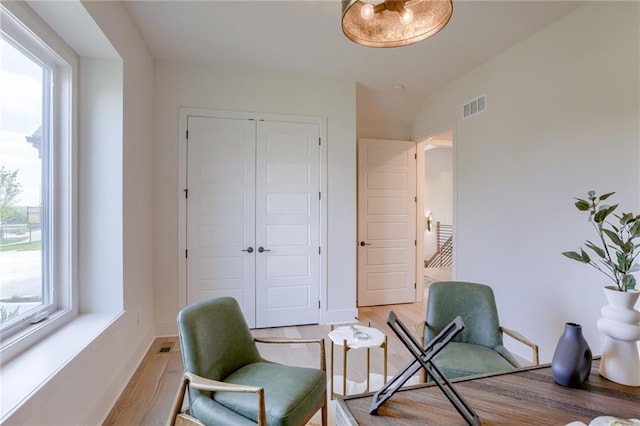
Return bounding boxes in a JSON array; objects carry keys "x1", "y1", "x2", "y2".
[{"x1": 413, "y1": 2, "x2": 640, "y2": 361}]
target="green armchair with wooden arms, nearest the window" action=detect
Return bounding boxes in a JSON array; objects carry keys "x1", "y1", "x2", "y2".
[{"x1": 169, "y1": 297, "x2": 327, "y2": 426}]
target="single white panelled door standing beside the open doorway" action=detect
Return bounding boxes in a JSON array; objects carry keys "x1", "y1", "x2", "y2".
[{"x1": 358, "y1": 139, "x2": 416, "y2": 306}]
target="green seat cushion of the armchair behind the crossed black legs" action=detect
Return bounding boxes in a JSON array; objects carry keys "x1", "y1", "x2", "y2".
[{"x1": 435, "y1": 342, "x2": 515, "y2": 379}]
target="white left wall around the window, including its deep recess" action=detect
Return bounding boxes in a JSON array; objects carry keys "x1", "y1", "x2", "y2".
[{"x1": 3, "y1": 1, "x2": 156, "y2": 425}]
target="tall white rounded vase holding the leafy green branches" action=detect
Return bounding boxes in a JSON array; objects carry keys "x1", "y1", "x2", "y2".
[{"x1": 598, "y1": 287, "x2": 640, "y2": 386}]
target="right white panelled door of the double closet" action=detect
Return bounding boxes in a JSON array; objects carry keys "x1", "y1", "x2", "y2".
[{"x1": 256, "y1": 121, "x2": 320, "y2": 327}]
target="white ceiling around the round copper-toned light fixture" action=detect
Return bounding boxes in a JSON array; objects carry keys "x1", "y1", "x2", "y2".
[{"x1": 124, "y1": 0, "x2": 581, "y2": 136}]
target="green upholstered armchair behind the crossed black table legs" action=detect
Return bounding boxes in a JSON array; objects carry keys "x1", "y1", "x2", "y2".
[{"x1": 421, "y1": 281, "x2": 539, "y2": 379}]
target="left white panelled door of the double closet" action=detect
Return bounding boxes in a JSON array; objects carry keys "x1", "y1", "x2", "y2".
[{"x1": 187, "y1": 117, "x2": 256, "y2": 327}]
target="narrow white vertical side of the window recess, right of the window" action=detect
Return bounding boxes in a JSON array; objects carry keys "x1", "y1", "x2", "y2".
[{"x1": 78, "y1": 58, "x2": 123, "y2": 313}]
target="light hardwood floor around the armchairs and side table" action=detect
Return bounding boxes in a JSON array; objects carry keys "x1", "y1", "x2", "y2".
[{"x1": 104, "y1": 302, "x2": 425, "y2": 426}]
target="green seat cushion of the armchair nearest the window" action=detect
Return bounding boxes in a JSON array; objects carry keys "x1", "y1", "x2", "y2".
[{"x1": 213, "y1": 362, "x2": 327, "y2": 426}]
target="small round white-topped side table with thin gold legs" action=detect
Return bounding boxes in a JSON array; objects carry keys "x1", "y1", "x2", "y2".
[{"x1": 329, "y1": 324, "x2": 387, "y2": 399}]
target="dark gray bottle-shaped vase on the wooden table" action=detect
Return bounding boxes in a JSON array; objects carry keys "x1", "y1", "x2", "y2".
[{"x1": 551, "y1": 322, "x2": 593, "y2": 388}]
